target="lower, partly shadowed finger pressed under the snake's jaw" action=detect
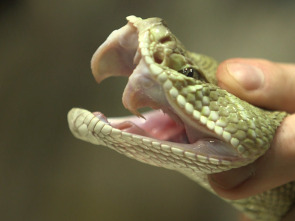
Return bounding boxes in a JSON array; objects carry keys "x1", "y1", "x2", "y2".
[{"x1": 208, "y1": 115, "x2": 295, "y2": 200}]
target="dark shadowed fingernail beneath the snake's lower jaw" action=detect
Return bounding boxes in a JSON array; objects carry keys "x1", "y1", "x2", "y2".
[{"x1": 209, "y1": 165, "x2": 254, "y2": 190}]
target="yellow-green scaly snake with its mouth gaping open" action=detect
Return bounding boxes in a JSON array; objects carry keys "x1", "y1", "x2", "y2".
[{"x1": 67, "y1": 15, "x2": 295, "y2": 221}]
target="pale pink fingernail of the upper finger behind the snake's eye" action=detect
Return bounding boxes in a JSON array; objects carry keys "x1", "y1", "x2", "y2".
[{"x1": 227, "y1": 63, "x2": 264, "y2": 90}]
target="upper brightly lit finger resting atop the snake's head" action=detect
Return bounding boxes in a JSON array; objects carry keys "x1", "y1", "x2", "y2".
[{"x1": 217, "y1": 58, "x2": 295, "y2": 112}]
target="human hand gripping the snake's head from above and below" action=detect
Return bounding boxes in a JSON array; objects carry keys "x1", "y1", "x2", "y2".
[{"x1": 208, "y1": 58, "x2": 295, "y2": 221}]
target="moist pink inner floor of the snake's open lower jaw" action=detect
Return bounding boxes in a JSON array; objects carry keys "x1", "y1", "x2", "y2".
[{"x1": 93, "y1": 110, "x2": 239, "y2": 161}]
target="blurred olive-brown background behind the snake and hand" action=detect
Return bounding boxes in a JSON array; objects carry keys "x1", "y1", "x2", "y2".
[{"x1": 0, "y1": 0, "x2": 295, "y2": 221}]
